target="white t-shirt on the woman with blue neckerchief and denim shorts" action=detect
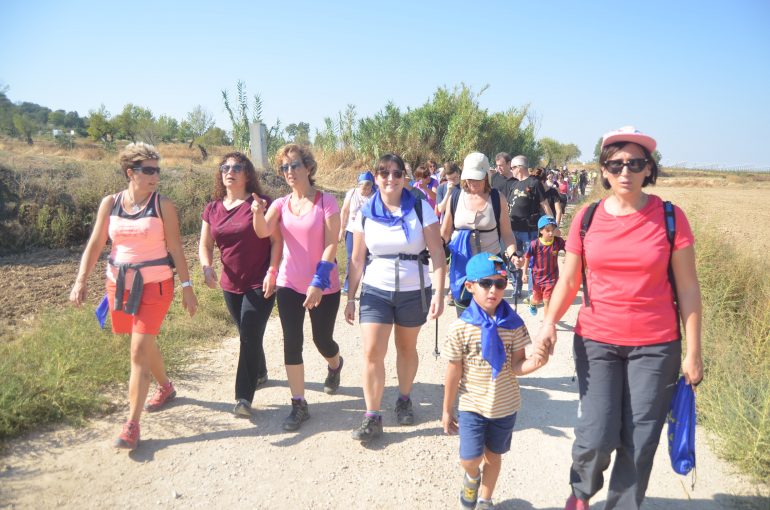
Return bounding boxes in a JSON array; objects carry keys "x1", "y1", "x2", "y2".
[{"x1": 352, "y1": 200, "x2": 438, "y2": 292}]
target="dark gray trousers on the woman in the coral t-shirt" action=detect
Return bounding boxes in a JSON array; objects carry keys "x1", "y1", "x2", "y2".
[{"x1": 570, "y1": 335, "x2": 682, "y2": 510}]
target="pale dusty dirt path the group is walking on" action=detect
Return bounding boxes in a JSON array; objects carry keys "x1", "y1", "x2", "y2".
[{"x1": 0, "y1": 194, "x2": 770, "y2": 510}]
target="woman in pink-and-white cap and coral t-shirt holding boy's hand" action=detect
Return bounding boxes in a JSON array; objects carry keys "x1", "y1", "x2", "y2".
[{"x1": 538, "y1": 127, "x2": 703, "y2": 510}]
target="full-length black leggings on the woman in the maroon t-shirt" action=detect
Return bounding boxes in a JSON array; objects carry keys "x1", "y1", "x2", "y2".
[{"x1": 223, "y1": 289, "x2": 275, "y2": 402}]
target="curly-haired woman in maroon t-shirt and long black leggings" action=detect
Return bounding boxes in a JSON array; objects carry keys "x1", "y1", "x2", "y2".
[{"x1": 198, "y1": 152, "x2": 283, "y2": 418}]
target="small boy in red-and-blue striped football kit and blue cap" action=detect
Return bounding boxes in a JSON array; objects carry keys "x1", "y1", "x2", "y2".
[{"x1": 520, "y1": 216, "x2": 566, "y2": 317}]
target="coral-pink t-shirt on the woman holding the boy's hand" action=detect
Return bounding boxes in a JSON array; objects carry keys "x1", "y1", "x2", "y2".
[{"x1": 566, "y1": 195, "x2": 694, "y2": 346}]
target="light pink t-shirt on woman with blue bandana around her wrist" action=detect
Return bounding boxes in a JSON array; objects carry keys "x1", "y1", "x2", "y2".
[{"x1": 270, "y1": 192, "x2": 340, "y2": 294}]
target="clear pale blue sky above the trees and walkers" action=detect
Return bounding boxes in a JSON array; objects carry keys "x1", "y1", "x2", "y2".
[{"x1": 0, "y1": 0, "x2": 770, "y2": 167}]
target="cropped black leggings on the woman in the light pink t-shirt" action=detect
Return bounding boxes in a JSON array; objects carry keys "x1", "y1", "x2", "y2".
[{"x1": 276, "y1": 287, "x2": 340, "y2": 365}]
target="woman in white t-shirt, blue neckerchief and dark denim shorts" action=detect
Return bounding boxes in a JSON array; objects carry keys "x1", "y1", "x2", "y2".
[{"x1": 345, "y1": 154, "x2": 446, "y2": 443}]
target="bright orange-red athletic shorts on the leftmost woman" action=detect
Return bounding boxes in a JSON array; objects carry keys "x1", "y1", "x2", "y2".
[{"x1": 107, "y1": 278, "x2": 174, "y2": 335}]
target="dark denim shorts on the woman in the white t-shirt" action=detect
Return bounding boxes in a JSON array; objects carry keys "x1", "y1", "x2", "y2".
[{"x1": 358, "y1": 284, "x2": 432, "y2": 328}]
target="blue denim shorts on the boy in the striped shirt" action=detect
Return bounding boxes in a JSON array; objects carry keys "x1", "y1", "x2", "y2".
[{"x1": 457, "y1": 411, "x2": 516, "y2": 460}]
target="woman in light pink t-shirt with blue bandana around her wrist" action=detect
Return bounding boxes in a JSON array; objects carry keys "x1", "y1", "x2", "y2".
[{"x1": 251, "y1": 144, "x2": 343, "y2": 431}]
